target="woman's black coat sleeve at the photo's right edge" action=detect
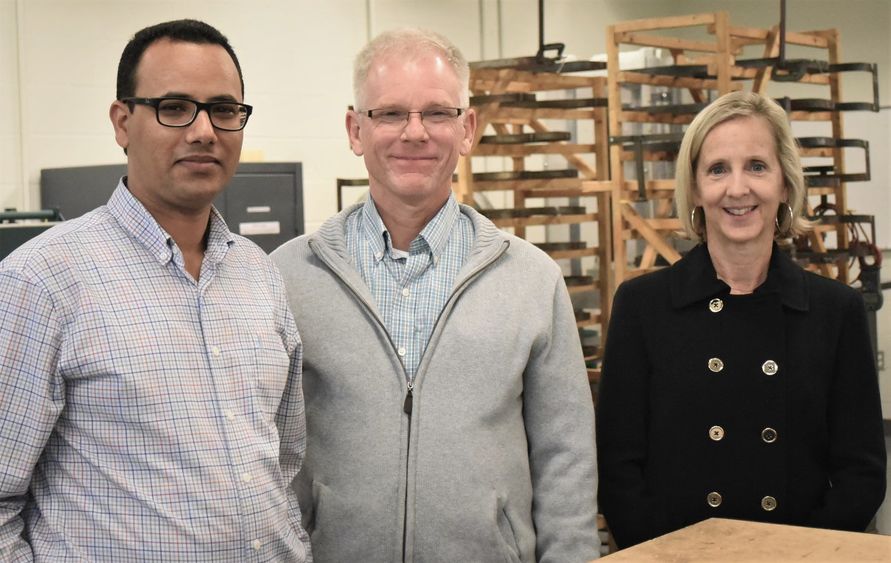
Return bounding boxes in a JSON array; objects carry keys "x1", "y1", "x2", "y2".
[{"x1": 808, "y1": 292, "x2": 887, "y2": 532}]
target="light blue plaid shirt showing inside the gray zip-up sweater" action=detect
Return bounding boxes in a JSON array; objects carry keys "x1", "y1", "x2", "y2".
[{"x1": 346, "y1": 195, "x2": 473, "y2": 381}]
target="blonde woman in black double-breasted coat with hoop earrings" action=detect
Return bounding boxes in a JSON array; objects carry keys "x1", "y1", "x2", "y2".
[{"x1": 597, "y1": 92, "x2": 886, "y2": 547}]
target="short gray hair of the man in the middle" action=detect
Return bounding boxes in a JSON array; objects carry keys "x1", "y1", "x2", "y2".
[{"x1": 353, "y1": 28, "x2": 470, "y2": 109}]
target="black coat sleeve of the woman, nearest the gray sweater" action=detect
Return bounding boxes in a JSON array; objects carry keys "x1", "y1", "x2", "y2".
[{"x1": 597, "y1": 284, "x2": 670, "y2": 548}]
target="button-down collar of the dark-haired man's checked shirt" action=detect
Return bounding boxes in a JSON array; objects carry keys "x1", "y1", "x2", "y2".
[{"x1": 106, "y1": 181, "x2": 235, "y2": 264}]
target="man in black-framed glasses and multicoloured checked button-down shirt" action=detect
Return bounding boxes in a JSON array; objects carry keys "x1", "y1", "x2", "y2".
[{"x1": 0, "y1": 20, "x2": 312, "y2": 562}]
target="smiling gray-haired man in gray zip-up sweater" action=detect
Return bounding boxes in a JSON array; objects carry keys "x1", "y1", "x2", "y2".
[{"x1": 273, "y1": 30, "x2": 600, "y2": 563}]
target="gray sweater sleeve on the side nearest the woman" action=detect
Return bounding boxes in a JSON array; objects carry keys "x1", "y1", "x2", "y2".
[{"x1": 523, "y1": 277, "x2": 600, "y2": 563}]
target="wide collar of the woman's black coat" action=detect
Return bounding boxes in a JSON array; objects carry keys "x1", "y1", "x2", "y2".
[{"x1": 669, "y1": 243, "x2": 808, "y2": 311}]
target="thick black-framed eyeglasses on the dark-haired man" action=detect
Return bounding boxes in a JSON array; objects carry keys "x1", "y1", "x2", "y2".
[{"x1": 121, "y1": 97, "x2": 254, "y2": 131}]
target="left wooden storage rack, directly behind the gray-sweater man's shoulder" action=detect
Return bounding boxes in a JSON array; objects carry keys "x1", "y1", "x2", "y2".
[{"x1": 455, "y1": 61, "x2": 613, "y2": 379}]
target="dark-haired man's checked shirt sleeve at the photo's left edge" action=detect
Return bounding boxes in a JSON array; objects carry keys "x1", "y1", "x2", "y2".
[{"x1": 0, "y1": 270, "x2": 65, "y2": 561}]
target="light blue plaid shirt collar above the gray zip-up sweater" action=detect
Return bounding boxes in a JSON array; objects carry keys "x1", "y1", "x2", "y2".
[{"x1": 361, "y1": 194, "x2": 461, "y2": 263}]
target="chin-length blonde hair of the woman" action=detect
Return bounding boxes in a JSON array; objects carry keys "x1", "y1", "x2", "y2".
[{"x1": 674, "y1": 91, "x2": 810, "y2": 240}]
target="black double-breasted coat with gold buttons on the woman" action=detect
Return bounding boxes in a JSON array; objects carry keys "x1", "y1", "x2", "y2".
[{"x1": 597, "y1": 245, "x2": 886, "y2": 547}]
